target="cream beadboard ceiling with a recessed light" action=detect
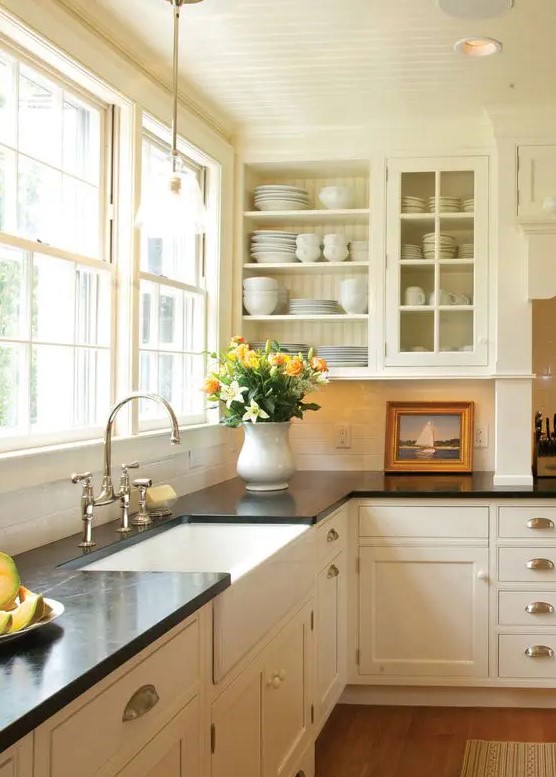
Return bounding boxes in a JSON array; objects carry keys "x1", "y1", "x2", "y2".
[{"x1": 58, "y1": 0, "x2": 556, "y2": 131}]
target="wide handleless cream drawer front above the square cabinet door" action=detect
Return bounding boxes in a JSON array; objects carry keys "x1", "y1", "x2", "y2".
[{"x1": 359, "y1": 505, "x2": 488, "y2": 539}]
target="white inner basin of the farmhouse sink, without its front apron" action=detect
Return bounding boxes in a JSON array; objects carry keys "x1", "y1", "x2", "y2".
[{"x1": 81, "y1": 523, "x2": 309, "y2": 582}]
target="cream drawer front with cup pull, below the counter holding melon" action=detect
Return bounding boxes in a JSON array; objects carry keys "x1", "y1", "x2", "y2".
[{"x1": 36, "y1": 619, "x2": 199, "y2": 777}]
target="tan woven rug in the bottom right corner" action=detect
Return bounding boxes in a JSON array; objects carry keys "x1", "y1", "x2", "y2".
[{"x1": 461, "y1": 739, "x2": 556, "y2": 777}]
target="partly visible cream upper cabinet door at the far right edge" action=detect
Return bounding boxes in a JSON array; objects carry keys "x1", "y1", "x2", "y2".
[{"x1": 517, "y1": 144, "x2": 556, "y2": 221}]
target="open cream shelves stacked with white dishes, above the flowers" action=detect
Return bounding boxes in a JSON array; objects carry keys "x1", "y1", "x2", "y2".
[{"x1": 236, "y1": 161, "x2": 370, "y2": 376}]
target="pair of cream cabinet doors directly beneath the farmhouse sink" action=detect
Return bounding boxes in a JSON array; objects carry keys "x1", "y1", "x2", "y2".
[{"x1": 211, "y1": 604, "x2": 312, "y2": 777}]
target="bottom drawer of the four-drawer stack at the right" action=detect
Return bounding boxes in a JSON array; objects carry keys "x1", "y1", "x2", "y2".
[{"x1": 498, "y1": 634, "x2": 556, "y2": 679}]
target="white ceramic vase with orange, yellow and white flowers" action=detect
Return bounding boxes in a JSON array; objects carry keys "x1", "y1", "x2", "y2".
[{"x1": 203, "y1": 337, "x2": 328, "y2": 491}]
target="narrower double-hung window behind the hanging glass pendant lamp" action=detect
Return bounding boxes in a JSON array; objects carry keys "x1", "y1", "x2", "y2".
[{"x1": 138, "y1": 130, "x2": 207, "y2": 429}]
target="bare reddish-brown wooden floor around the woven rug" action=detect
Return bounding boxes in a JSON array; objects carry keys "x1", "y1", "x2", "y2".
[{"x1": 316, "y1": 704, "x2": 556, "y2": 777}]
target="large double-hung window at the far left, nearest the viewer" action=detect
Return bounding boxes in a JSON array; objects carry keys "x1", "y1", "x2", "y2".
[{"x1": 0, "y1": 47, "x2": 114, "y2": 450}]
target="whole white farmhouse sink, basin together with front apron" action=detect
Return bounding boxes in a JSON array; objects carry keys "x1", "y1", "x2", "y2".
[{"x1": 81, "y1": 523, "x2": 316, "y2": 683}]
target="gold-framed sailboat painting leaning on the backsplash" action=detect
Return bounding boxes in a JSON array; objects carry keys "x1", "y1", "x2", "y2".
[{"x1": 384, "y1": 402, "x2": 474, "y2": 473}]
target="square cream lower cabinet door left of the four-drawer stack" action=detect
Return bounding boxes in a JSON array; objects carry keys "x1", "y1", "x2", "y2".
[{"x1": 359, "y1": 544, "x2": 489, "y2": 678}]
